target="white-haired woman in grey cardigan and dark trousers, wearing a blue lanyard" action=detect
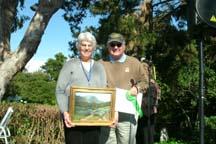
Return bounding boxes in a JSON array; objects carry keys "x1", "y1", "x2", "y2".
[{"x1": 56, "y1": 32, "x2": 106, "y2": 144}]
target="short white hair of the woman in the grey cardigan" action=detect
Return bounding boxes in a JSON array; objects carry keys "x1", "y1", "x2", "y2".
[{"x1": 76, "y1": 32, "x2": 97, "y2": 49}]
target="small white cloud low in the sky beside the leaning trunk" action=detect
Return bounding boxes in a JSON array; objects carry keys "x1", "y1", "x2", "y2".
[{"x1": 25, "y1": 59, "x2": 46, "y2": 72}]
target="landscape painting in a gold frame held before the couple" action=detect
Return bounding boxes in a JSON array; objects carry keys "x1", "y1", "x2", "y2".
[{"x1": 69, "y1": 86, "x2": 116, "y2": 126}]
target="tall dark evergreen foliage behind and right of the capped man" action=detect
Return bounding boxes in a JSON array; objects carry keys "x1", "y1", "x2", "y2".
[{"x1": 81, "y1": 0, "x2": 216, "y2": 143}]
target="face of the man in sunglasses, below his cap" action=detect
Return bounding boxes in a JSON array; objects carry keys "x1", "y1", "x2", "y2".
[{"x1": 108, "y1": 41, "x2": 125, "y2": 60}]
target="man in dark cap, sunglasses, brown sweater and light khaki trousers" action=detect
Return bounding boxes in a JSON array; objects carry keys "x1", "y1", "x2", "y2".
[{"x1": 99, "y1": 33, "x2": 148, "y2": 144}]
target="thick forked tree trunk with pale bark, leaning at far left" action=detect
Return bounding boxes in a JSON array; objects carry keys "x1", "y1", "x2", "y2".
[{"x1": 0, "y1": 0, "x2": 63, "y2": 101}]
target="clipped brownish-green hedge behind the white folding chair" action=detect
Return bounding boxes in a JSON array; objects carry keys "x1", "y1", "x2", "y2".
[{"x1": 0, "y1": 102, "x2": 64, "y2": 144}]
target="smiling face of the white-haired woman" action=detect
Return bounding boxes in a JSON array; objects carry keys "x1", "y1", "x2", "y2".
[{"x1": 79, "y1": 40, "x2": 93, "y2": 62}]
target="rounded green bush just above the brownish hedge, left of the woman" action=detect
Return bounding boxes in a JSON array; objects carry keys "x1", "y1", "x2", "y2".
[{"x1": 4, "y1": 71, "x2": 56, "y2": 105}]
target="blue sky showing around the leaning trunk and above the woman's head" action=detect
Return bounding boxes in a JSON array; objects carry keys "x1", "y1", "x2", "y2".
[{"x1": 11, "y1": 0, "x2": 98, "y2": 71}]
